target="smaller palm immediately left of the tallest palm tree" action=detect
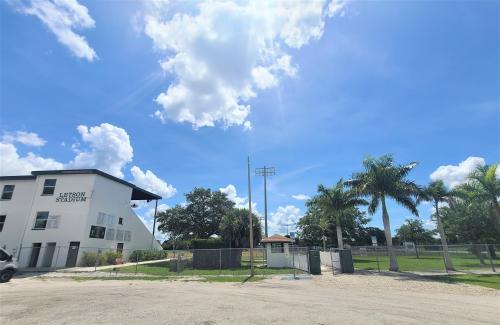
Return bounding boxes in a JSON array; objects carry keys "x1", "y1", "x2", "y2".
[{"x1": 316, "y1": 178, "x2": 368, "y2": 249}]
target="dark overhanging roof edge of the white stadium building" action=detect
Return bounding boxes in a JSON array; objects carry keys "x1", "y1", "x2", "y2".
[{"x1": 0, "y1": 169, "x2": 161, "y2": 201}]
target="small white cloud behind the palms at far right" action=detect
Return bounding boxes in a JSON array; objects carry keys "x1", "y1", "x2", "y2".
[{"x1": 430, "y1": 157, "x2": 486, "y2": 188}]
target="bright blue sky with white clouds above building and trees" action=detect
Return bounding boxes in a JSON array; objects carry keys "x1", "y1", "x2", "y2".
[{"x1": 0, "y1": 0, "x2": 500, "y2": 238}]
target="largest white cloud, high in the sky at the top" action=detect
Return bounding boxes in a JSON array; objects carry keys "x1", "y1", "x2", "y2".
[{"x1": 144, "y1": 0, "x2": 344, "y2": 130}]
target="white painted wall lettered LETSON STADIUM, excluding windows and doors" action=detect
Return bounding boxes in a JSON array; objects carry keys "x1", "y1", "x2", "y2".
[{"x1": 0, "y1": 174, "x2": 161, "y2": 267}]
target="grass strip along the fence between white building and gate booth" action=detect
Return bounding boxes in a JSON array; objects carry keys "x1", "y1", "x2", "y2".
[{"x1": 110, "y1": 262, "x2": 303, "y2": 276}]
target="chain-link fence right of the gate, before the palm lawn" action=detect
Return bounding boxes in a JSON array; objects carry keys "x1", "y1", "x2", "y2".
[{"x1": 351, "y1": 244, "x2": 500, "y2": 272}]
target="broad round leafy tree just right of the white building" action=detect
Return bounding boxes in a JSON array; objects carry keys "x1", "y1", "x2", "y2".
[{"x1": 157, "y1": 188, "x2": 234, "y2": 240}]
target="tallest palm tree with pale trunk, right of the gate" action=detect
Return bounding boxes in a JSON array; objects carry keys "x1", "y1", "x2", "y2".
[{"x1": 346, "y1": 155, "x2": 421, "y2": 272}]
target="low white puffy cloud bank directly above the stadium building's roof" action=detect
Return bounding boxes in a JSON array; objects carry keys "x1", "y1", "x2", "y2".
[{"x1": 0, "y1": 123, "x2": 177, "y2": 202}]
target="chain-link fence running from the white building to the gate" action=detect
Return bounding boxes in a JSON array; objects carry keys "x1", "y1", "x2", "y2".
[{"x1": 17, "y1": 245, "x2": 309, "y2": 276}]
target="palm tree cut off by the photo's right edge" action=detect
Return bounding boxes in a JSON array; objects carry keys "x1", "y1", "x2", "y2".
[{"x1": 469, "y1": 164, "x2": 500, "y2": 231}]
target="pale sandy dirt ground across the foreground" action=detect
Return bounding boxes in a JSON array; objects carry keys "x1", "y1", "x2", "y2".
[{"x1": 0, "y1": 274, "x2": 500, "y2": 324}]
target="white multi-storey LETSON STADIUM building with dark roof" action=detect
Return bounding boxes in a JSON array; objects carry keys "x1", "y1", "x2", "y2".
[{"x1": 0, "y1": 169, "x2": 161, "y2": 267}]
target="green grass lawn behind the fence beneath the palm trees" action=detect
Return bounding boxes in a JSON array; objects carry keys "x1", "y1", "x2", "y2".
[{"x1": 353, "y1": 253, "x2": 500, "y2": 271}]
